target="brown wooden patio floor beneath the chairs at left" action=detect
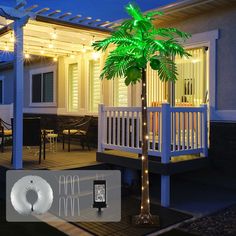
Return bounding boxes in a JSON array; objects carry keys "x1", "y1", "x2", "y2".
[{"x1": 0, "y1": 143, "x2": 101, "y2": 170}]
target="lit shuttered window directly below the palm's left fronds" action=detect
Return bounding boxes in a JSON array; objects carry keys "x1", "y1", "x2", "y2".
[{"x1": 113, "y1": 78, "x2": 128, "y2": 107}]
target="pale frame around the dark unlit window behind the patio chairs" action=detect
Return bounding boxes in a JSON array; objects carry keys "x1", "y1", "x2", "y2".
[{"x1": 29, "y1": 66, "x2": 57, "y2": 107}]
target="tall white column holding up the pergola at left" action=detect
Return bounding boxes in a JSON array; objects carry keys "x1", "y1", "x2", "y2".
[{"x1": 13, "y1": 17, "x2": 28, "y2": 169}]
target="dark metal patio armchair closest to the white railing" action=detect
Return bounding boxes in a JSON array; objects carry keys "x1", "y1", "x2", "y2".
[{"x1": 62, "y1": 116, "x2": 92, "y2": 152}]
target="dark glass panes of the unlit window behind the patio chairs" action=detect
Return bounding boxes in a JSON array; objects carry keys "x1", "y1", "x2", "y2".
[{"x1": 31, "y1": 72, "x2": 54, "y2": 103}]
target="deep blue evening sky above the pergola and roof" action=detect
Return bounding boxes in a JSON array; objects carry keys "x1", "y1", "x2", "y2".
[{"x1": 0, "y1": 0, "x2": 176, "y2": 21}]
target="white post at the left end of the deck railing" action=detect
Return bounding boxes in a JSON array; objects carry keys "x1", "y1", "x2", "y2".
[{"x1": 98, "y1": 104, "x2": 104, "y2": 152}]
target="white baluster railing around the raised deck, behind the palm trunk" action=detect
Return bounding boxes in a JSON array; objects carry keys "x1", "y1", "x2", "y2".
[{"x1": 98, "y1": 104, "x2": 208, "y2": 163}]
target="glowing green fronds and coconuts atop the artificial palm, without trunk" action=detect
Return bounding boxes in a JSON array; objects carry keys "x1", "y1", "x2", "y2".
[{"x1": 93, "y1": 4, "x2": 189, "y2": 85}]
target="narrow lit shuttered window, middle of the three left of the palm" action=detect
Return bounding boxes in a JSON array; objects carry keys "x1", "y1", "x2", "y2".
[{"x1": 89, "y1": 60, "x2": 101, "y2": 112}]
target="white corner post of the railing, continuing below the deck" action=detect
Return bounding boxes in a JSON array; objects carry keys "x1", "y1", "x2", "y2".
[{"x1": 161, "y1": 103, "x2": 171, "y2": 207}]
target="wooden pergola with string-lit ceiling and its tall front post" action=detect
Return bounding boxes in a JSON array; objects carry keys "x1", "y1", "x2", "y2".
[{"x1": 0, "y1": 0, "x2": 112, "y2": 169}]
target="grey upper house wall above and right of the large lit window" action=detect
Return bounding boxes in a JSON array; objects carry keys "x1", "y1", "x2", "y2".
[{"x1": 158, "y1": 6, "x2": 236, "y2": 112}]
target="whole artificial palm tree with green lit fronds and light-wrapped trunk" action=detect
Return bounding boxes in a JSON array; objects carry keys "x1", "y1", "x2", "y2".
[{"x1": 93, "y1": 4, "x2": 189, "y2": 225}]
